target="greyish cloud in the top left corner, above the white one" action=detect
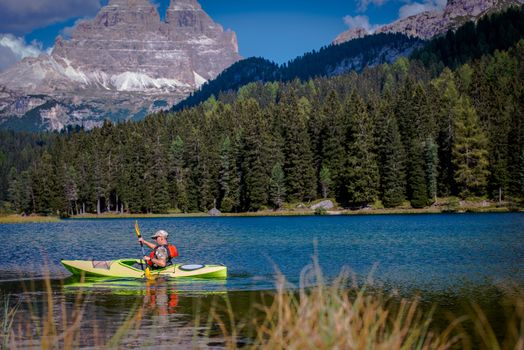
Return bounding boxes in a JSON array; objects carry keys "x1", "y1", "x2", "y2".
[{"x1": 0, "y1": 0, "x2": 101, "y2": 35}]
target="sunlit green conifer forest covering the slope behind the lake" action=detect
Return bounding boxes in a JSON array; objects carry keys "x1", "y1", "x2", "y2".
[{"x1": 4, "y1": 36, "x2": 524, "y2": 213}]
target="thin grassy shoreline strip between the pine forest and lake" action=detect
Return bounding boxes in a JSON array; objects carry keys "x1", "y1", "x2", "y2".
[{"x1": 0, "y1": 207, "x2": 524, "y2": 225}]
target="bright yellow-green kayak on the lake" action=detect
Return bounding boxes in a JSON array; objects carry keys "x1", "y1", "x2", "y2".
[{"x1": 61, "y1": 259, "x2": 227, "y2": 278}]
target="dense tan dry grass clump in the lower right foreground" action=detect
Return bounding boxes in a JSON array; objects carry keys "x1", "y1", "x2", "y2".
[{"x1": 247, "y1": 263, "x2": 524, "y2": 350}]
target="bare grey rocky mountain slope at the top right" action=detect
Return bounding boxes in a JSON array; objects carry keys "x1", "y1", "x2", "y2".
[{"x1": 333, "y1": 0, "x2": 524, "y2": 44}]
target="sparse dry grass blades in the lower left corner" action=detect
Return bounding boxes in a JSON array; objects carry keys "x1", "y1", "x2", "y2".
[{"x1": 0, "y1": 276, "x2": 142, "y2": 350}]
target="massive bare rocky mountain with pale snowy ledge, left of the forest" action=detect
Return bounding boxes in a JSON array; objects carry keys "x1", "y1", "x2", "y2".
[{"x1": 0, "y1": 0, "x2": 241, "y2": 129}]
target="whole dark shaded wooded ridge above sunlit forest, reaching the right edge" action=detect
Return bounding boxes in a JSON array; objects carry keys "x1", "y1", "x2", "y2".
[{"x1": 174, "y1": 6, "x2": 524, "y2": 111}]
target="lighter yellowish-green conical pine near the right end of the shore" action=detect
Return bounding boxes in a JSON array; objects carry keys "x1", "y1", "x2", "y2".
[{"x1": 453, "y1": 97, "x2": 489, "y2": 198}]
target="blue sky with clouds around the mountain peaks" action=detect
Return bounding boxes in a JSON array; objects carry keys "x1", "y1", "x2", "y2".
[{"x1": 0, "y1": 0, "x2": 446, "y2": 70}]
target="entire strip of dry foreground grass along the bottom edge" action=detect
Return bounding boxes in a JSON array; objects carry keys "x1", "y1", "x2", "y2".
[{"x1": 0, "y1": 264, "x2": 524, "y2": 350}]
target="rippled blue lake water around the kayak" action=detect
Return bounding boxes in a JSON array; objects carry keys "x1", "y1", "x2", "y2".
[{"x1": 0, "y1": 213, "x2": 524, "y2": 347}]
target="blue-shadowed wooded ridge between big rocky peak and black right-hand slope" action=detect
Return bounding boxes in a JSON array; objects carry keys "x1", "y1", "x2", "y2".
[{"x1": 174, "y1": 33, "x2": 423, "y2": 110}]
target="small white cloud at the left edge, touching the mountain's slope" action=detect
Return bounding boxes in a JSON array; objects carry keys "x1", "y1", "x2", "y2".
[{"x1": 0, "y1": 34, "x2": 44, "y2": 72}]
